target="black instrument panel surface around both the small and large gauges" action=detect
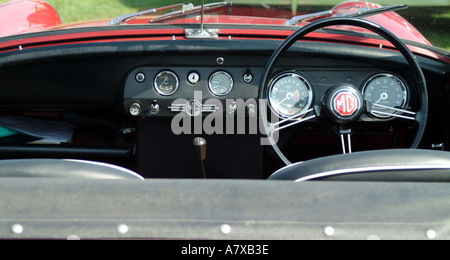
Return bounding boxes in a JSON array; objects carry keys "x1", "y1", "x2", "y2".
[{"x1": 123, "y1": 65, "x2": 417, "y2": 122}]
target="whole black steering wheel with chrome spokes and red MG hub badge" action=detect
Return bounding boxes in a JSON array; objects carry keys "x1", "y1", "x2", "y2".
[{"x1": 258, "y1": 17, "x2": 428, "y2": 169}]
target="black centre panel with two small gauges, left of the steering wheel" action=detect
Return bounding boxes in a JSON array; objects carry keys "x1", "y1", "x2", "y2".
[{"x1": 123, "y1": 66, "x2": 263, "y2": 117}]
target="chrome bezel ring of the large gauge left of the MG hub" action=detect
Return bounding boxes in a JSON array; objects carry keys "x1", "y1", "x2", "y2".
[{"x1": 267, "y1": 72, "x2": 314, "y2": 119}]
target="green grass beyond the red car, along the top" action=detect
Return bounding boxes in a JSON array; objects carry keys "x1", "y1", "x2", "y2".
[{"x1": 0, "y1": 0, "x2": 450, "y2": 51}]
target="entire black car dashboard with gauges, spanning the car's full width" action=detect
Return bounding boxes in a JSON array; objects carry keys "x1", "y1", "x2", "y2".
[{"x1": 0, "y1": 31, "x2": 450, "y2": 179}]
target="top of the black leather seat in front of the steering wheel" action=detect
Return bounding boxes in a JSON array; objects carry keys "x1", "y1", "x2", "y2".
[{"x1": 269, "y1": 149, "x2": 450, "y2": 182}]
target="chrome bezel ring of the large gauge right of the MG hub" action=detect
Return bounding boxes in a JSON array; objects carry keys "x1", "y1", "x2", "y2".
[{"x1": 361, "y1": 72, "x2": 410, "y2": 119}]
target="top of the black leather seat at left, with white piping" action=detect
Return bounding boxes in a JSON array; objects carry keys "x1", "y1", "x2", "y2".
[{"x1": 0, "y1": 159, "x2": 143, "y2": 180}]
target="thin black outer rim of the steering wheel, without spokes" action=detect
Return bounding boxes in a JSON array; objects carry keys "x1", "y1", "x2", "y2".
[{"x1": 258, "y1": 17, "x2": 428, "y2": 165}]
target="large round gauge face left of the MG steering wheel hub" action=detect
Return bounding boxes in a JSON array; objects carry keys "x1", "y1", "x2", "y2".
[{"x1": 269, "y1": 73, "x2": 313, "y2": 117}]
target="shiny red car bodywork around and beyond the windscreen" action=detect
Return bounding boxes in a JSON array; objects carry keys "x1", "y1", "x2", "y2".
[{"x1": 0, "y1": 0, "x2": 449, "y2": 62}]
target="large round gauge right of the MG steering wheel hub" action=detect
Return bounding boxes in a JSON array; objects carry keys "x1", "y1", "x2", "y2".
[{"x1": 362, "y1": 73, "x2": 408, "y2": 118}]
